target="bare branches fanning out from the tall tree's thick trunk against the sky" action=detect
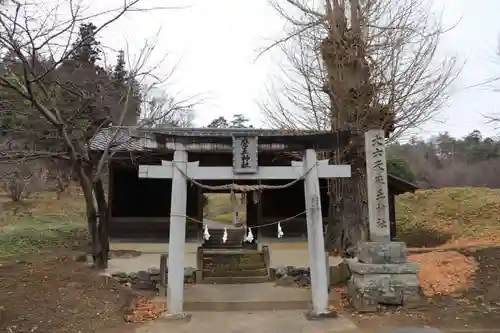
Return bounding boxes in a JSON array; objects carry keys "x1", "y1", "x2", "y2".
[{"x1": 259, "y1": 0, "x2": 461, "y2": 139}]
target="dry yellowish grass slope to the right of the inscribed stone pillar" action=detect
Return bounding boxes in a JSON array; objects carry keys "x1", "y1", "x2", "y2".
[{"x1": 396, "y1": 187, "x2": 500, "y2": 247}]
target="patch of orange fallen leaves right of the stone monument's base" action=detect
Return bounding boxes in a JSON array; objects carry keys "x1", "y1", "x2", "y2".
[{"x1": 408, "y1": 251, "x2": 478, "y2": 297}]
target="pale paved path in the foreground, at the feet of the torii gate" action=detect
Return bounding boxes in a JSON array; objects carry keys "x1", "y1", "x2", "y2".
[{"x1": 135, "y1": 310, "x2": 360, "y2": 333}]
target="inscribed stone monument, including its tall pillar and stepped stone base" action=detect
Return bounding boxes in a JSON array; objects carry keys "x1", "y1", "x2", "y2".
[{"x1": 346, "y1": 130, "x2": 421, "y2": 311}]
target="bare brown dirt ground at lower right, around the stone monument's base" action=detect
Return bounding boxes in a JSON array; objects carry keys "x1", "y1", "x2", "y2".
[{"x1": 344, "y1": 247, "x2": 500, "y2": 331}]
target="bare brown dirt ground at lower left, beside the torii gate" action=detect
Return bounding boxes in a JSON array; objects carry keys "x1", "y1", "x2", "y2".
[{"x1": 0, "y1": 252, "x2": 148, "y2": 333}]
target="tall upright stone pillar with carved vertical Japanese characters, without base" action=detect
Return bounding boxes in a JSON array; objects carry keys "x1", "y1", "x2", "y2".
[{"x1": 365, "y1": 129, "x2": 391, "y2": 242}]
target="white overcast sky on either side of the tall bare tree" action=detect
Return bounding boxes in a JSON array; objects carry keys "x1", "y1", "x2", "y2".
[{"x1": 91, "y1": 0, "x2": 500, "y2": 137}]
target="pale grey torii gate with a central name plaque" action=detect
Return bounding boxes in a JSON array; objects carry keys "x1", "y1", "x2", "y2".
[{"x1": 139, "y1": 136, "x2": 351, "y2": 318}]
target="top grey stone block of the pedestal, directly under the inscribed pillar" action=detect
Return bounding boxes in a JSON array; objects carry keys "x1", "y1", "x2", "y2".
[{"x1": 356, "y1": 242, "x2": 408, "y2": 264}]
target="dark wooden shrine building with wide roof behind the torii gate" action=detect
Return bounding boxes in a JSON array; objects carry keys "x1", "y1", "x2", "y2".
[{"x1": 91, "y1": 128, "x2": 417, "y2": 241}]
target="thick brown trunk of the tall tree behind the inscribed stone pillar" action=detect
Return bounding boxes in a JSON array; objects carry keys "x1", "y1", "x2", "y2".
[{"x1": 321, "y1": 5, "x2": 373, "y2": 255}]
